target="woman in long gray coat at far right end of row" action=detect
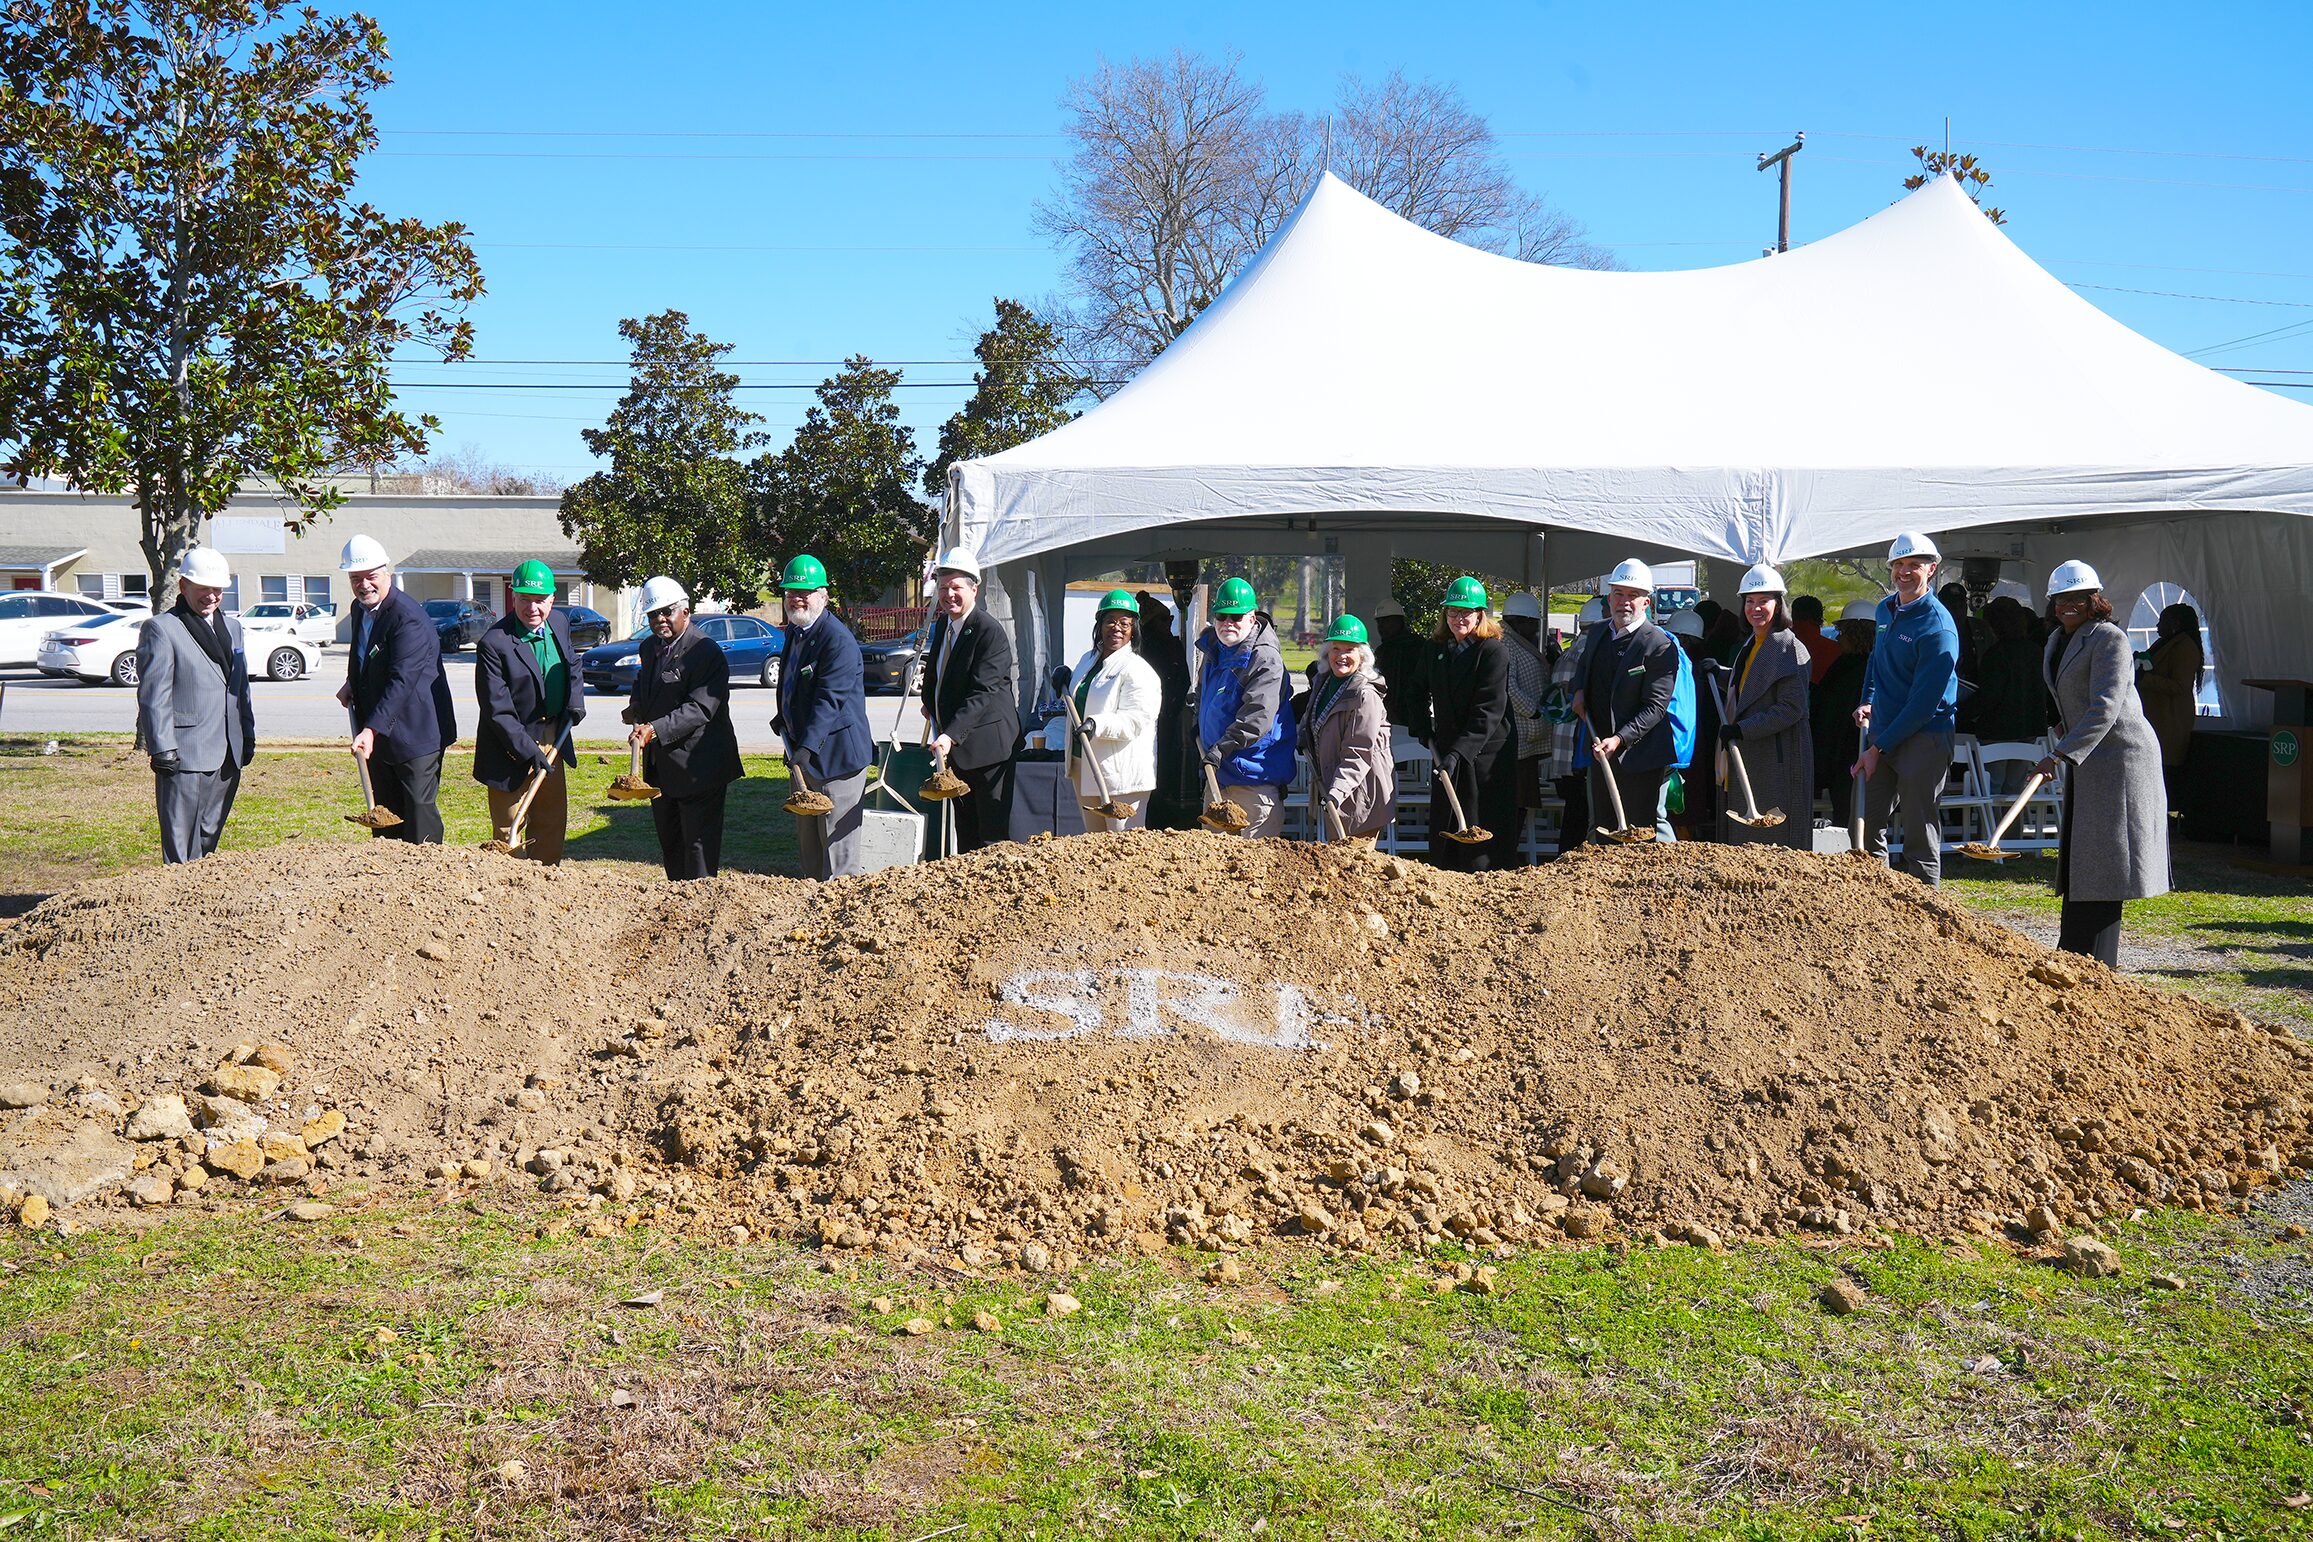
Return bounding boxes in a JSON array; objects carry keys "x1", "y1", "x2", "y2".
[{"x1": 2035, "y1": 562, "x2": 2167, "y2": 966}]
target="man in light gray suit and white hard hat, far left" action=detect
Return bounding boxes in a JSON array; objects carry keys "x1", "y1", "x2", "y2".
[{"x1": 136, "y1": 546, "x2": 257, "y2": 862}]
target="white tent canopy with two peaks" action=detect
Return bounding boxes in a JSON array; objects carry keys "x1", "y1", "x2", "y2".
[{"x1": 948, "y1": 178, "x2": 2313, "y2": 714}]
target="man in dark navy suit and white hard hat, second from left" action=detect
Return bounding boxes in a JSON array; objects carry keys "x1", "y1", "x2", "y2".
[{"x1": 338, "y1": 536, "x2": 458, "y2": 846}]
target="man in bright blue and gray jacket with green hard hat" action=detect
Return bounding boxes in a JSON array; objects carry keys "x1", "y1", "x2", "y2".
[{"x1": 1196, "y1": 578, "x2": 1293, "y2": 839}]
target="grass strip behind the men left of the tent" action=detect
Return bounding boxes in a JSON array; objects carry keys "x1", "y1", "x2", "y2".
[{"x1": 0, "y1": 733, "x2": 796, "y2": 915}]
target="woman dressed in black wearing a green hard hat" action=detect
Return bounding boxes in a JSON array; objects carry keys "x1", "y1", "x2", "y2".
[{"x1": 1429, "y1": 576, "x2": 1517, "y2": 872}]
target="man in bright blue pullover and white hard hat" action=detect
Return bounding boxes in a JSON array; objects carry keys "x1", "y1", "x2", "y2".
[{"x1": 1850, "y1": 532, "x2": 1959, "y2": 885}]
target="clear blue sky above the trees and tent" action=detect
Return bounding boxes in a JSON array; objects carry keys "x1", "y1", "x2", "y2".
[{"x1": 361, "y1": 0, "x2": 2313, "y2": 481}]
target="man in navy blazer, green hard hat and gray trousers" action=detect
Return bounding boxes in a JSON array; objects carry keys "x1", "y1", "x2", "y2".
[{"x1": 770, "y1": 557, "x2": 874, "y2": 881}]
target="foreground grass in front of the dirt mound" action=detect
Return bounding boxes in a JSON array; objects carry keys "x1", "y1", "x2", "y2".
[{"x1": 0, "y1": 1200, "x2": 2313, "y2": 1540}]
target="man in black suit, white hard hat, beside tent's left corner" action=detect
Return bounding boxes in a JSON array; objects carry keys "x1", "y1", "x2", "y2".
[{"x1": 923, "y1": 546, "x2": 1020, "y2": 851}]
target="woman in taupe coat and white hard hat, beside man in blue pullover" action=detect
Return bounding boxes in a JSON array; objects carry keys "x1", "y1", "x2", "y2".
[{"x1": 1719, "y1": 562, "x2": 1816, "y2": 851}]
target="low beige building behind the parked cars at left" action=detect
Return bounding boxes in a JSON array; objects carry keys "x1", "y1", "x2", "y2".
[{"x1": 0, "y1": 483, "x2": 629, "y2": 640}]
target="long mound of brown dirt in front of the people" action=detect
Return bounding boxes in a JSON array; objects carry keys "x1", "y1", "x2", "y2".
[{"x1": 0, "y1": 832, "x2": 2313, "y2": 1267}]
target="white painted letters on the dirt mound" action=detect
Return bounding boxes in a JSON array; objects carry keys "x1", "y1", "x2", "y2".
[{"x1": 988, "y1": 969, "x2": 1355, "y2": 1050}]
